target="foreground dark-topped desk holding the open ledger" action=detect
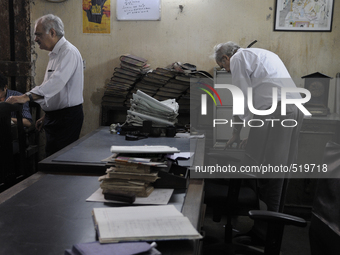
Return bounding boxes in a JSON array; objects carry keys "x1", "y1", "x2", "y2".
[{"x1": 0, "y1": 127, "x2": 204, "y2": 255}]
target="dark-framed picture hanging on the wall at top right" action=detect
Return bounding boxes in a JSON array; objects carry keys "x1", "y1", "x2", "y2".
[{"x1": 274, "y1": 0, "x2": 334, "y2": 32}]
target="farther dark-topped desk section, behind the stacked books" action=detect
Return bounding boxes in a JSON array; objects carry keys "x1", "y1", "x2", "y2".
[{"x1": 38, "y1": 126, "x2": 201, "y2": 174}]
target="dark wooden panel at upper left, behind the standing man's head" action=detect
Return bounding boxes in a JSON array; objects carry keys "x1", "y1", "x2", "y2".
[{"x1": 0, "y1": 0, "x2": 31, "y2": 93}]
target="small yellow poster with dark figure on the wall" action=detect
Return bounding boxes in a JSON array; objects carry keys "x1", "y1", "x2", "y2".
[{"x1": 83, "y1": 0, "x2": 111, "y2": 34}]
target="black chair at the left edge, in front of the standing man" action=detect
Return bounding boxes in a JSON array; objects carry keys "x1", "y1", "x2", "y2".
[{"x1": 0, "y1": 102, "x2": 26, "y2": 191}]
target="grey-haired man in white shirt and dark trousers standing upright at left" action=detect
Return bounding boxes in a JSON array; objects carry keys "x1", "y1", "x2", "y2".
[{"x1": 7, "y1": 14, "x2": 84, "y2": 156}]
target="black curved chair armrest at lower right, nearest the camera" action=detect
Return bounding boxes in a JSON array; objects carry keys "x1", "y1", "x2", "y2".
[{"x1": 249, "y1": 210, "x2": 307, "y2": 227}]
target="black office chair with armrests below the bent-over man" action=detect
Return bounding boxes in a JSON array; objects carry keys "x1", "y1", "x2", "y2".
[{"x1": 205, "y1": 151, "x2": 290, "y2": 254}]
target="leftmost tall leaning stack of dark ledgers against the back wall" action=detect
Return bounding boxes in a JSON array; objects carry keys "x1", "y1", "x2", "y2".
[{"x1": 102, "y1": 54, "x2": 150, "y2": 106}]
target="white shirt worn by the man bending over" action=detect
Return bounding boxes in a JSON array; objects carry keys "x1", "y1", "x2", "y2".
[{"x1": 230, "y1": 48, "x2": 301, "y2": 120}]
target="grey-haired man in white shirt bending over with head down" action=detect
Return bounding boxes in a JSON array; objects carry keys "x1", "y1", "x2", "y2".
[{"x1": 214, "y1": 42, "x2": 304, "y2": 245}]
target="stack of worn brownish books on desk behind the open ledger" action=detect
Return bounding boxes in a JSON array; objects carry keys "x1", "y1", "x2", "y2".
[{"x1": 99, "y1": 156, "x2": 167, "y2": 197}]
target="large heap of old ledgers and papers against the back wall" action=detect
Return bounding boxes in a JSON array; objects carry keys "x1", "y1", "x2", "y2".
[{"x1": 102, "y1": 57, "x2": 212, "y2": 121}]
